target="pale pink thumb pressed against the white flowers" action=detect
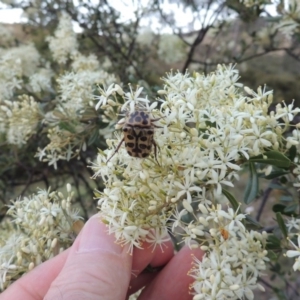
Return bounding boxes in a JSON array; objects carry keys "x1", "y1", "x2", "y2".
[{"x1": 44, "y1": 215, "x2": 132, "y2": 300}]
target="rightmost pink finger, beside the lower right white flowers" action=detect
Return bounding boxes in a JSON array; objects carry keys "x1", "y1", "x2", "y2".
[{"x1": 139, "y1": 246, "x2": 204, "y2": 300}]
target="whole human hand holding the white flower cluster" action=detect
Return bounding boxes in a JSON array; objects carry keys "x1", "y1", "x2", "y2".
[{"x1": 0, "y1": 215, "x2": 203, "y2": 300}]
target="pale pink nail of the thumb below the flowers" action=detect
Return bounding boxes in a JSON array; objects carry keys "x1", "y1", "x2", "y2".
[{"x1": 78, "y1": 215, "x2": 124, "y2": 254}]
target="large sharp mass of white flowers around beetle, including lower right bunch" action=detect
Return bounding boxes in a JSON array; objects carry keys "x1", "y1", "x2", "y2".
[{"x1": 92, "y1": 66, "x2": 299, "y2": 299}]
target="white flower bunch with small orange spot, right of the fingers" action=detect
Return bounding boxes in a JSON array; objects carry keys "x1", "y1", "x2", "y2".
[{"x1": 191, "y1": 205, "x2": 269, "y2": 300}]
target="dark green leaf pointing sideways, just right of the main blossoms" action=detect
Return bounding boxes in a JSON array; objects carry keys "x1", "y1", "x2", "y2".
[{"x1": 249, "y1": 150, "x2": 291, "y2": 168}]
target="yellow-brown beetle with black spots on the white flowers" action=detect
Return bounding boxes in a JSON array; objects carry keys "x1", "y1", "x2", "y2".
[{"x1": 107, "y1": 110, "x2": 161, "y2": 164}]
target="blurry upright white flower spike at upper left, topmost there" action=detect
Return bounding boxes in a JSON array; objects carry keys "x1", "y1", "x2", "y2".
[{"x1": 47, "y1": 12, "x2": 78, "y2": 64}]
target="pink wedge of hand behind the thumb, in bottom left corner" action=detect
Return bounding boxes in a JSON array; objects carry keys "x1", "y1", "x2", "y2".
[{"x1": 0, "y1": 249, "x2": 70, "y2": 300}]
